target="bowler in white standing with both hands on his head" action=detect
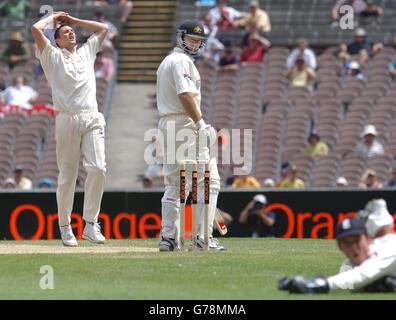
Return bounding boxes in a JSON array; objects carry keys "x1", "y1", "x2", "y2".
[{"x1": 31, "y1": 12, "x2": 107, "y2": 246}]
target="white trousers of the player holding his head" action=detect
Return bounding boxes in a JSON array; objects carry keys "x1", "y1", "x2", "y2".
[{"x1": 55, "y1": 111, "x2": 106, "y2": 226}]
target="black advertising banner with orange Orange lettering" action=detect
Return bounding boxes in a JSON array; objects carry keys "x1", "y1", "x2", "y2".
[{"x1": 0, "y1": 189, "x2": 396, "y2": 240}]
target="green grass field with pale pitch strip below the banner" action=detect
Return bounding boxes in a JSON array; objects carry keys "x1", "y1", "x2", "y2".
[{"x1": 0, "y1": 238, "x2": 396, "y2": 300}]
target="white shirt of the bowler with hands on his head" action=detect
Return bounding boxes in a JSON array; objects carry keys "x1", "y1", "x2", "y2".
[{"x1": 36, "y1": 34, "x2": 100, "y2": 112}]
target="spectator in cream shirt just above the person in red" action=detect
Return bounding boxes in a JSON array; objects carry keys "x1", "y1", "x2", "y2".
[{"x1": 235, "y1": 0, "x2": 271, "y2": 47}]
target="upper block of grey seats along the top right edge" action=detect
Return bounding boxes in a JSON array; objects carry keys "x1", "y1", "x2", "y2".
[{"x1": 176, "y1": 0, "x2": 396, "y2": 48}]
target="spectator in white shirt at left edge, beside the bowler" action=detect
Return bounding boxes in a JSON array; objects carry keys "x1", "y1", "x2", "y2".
[{"x1": 0, "y1": 76, "x2": 38, "y2": 109}]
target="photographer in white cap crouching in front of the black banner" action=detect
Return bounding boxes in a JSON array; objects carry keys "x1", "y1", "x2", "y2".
[{"x1": 239, "y1": 194, "x2": 275, "y2": 238}]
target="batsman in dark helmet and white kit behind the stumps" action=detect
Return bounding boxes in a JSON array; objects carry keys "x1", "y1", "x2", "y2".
[{"x1": 157, "y1": 20, "x2": 224, "y2": 251}]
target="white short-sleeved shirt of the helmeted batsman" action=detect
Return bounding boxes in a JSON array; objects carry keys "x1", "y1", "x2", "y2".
[{"x1": 157, "y1": 48, "x2": 201, "y2": 116}]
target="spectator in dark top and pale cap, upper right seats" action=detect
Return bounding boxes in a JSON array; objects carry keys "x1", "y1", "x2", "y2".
[{"x1": 348, "y1": 28, "x2": 384, "y2": 64}]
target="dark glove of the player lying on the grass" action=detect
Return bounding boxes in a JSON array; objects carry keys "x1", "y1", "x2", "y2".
[{"x1": 278, "y1": 276, "x2": 329, "y2": 293}]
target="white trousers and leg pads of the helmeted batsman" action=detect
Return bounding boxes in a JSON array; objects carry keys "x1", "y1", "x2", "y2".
[{"x1": 158, "y1": 114, "x2": 220, "y2": 239}]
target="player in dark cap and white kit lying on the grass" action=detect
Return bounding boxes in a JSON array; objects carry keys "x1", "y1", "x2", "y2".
[{"x1": 278, "y1": 217, "x2": 396, "y2": 293}]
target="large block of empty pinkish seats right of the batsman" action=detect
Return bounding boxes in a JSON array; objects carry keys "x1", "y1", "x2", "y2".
[{"x1": 200, "y1": 38, "x2": 396, "y2": 187}]
